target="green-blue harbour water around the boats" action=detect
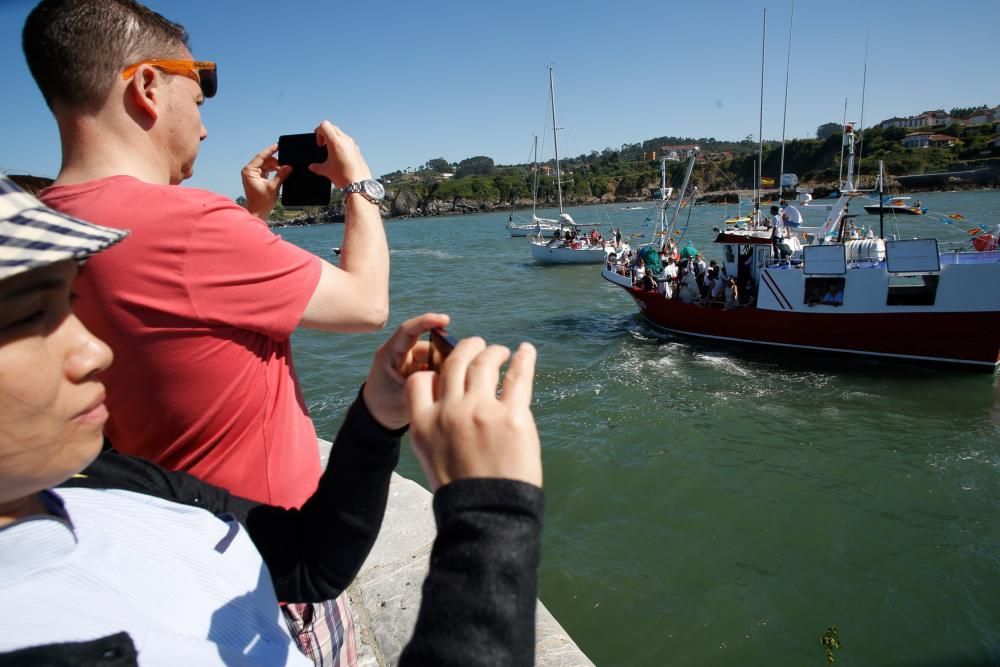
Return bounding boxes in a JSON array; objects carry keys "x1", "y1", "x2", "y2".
[{"x1": 281, "y1": 191, "x2": 1000, "y2": 666}]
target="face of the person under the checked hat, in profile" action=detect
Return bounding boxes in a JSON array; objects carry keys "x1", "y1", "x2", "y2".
[{"x1": 0, "y1": 261, "x2": 111, "y2": 511}]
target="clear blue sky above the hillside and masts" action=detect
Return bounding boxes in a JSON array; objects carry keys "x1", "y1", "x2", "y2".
[{"x1": 0, "y1": 0, "x2": 1000, "y2": 197}]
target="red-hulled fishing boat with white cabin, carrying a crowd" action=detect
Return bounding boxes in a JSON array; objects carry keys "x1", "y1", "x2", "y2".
[{"x1": 602, "y1": 125, "x2": 1000, "y2": 371}]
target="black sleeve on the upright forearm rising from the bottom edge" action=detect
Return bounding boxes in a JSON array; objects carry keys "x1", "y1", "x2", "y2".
[{"x1": 400, "y1": 479, "x2": 545, "y2": 665}]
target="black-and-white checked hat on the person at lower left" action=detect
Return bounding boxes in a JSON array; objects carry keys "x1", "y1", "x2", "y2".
[{"x1": 0, "y1": 174, "x2": 128, "y2": 280}]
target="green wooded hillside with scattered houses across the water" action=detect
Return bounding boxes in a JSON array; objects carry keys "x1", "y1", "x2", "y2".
[{"x1": 266, "y1": 105, "x2": 1000, "y2": 224}]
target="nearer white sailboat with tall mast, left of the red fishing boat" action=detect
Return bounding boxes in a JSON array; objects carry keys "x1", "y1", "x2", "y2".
[{"x1": 529, "y1": 67, "x2": 628, "y2": 264}]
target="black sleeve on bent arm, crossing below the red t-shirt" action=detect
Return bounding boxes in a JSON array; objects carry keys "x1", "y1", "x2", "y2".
[{"x1": 64, "y1": 394, "x2": 402, "y2": 602}]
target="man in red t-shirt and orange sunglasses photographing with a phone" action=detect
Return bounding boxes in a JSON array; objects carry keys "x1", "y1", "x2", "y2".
[{"x1": 24, "y1": 0, "x2": 389, "y2": 506}]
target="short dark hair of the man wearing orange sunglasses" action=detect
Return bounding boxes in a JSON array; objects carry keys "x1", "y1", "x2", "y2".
[{"x1": 21, "y1": 0, "x2": 188, "y2": 111}]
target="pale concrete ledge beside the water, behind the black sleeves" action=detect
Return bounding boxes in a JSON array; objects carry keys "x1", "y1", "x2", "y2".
[{"x1": 347, "y1": 473, "x2": 593, "y2": 667}]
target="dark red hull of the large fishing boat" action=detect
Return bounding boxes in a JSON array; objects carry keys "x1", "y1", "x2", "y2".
[{"x1": 600, "y1": 272, "x2": 1000, "y2": 371}]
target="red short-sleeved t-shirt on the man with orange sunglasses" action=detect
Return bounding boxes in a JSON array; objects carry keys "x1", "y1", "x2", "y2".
[{"x1": 42, "y1": 176, "x2": 322, "y2": 507}]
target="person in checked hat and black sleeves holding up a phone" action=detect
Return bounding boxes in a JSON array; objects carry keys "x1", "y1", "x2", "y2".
[{"x1": 0, "y1": 177, "x2": 544, "y2": 665}]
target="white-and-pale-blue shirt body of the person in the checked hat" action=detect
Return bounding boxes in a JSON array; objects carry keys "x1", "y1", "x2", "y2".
[{"x1": 0, "y1": 489, "x2": 312, "y2": 667}]
